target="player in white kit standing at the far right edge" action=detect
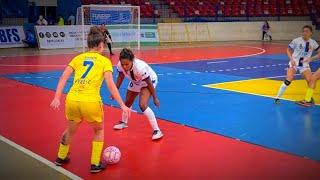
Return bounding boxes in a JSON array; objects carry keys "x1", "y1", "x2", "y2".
[{"x1": 275, "y1": 25, "x2": 319, "y2": 103}]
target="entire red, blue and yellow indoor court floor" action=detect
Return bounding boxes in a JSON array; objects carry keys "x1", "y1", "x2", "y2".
[{"x1": 0, "y1": 42, "x2": 320, "y2": 179}]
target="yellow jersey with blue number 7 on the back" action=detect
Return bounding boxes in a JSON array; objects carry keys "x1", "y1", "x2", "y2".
[{"x1": 66, "y1": 51, "x2": 113, "y2": 102}]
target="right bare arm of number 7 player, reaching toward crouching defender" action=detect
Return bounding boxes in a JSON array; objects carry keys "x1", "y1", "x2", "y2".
[{"x1": 104, "y1": 72, "x2": 131, "y2": 117}]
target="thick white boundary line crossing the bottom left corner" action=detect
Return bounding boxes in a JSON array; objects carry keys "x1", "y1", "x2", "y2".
[{"x1": 0, "y1": 135, "x2": 82, "y2": 179}]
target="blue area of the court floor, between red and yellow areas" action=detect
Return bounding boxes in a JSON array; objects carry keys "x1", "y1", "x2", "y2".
[{"x1": 6, "y1": 54, "x2": 320, "y2": 161}]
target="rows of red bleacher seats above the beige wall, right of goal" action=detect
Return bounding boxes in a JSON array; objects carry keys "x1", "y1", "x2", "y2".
[{"x1": 162, "y1": 0, "x2": 320, "y2": 17}]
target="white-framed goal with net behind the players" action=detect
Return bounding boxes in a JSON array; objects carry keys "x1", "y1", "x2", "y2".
[{"x1": 75, "y1": 5, "x2": 141, "y2": 52}]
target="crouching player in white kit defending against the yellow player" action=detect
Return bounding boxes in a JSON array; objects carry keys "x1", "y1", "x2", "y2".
[{"x1": 114, "y1": 48, "x2": 163, "y2": 140}]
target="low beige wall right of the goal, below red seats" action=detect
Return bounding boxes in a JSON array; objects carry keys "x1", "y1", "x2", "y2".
[{"x1": 158, "y1": 21, "x2": 320, "y2": 42}]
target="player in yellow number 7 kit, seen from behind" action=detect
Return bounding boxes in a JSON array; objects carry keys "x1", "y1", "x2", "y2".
[{"x1": 51, "y1": 27, "x2": 131, "y2": 173}]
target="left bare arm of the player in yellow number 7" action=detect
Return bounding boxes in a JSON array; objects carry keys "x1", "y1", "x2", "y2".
[{"x1": 50, "y1": 66, "x2": 73, "y2": 109}]
